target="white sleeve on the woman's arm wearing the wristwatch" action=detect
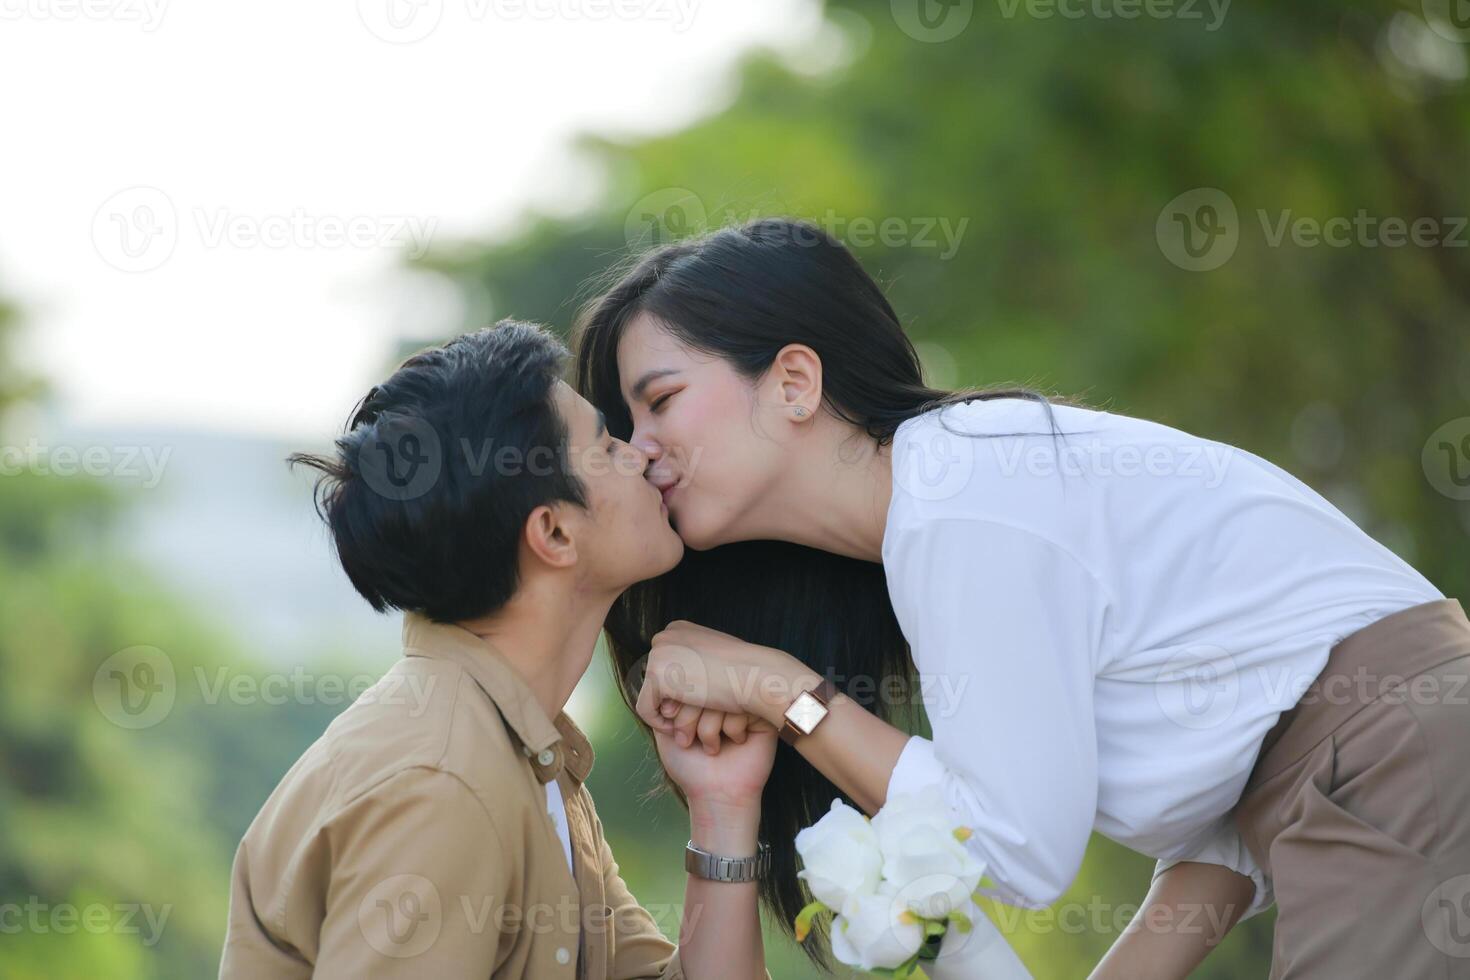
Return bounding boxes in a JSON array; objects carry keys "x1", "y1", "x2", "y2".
[{"x1": 885, "y1": 517, "x2": 1107, "y2": 908}]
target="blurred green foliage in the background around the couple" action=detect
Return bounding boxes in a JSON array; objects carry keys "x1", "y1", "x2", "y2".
[{"x1": 0, "y1": 0, "x2": 1470, "y2": 980}]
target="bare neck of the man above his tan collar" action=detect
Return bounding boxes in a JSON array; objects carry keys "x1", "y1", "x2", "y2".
[{"x1": 446, "y1": 573, "x2": 617, "y2": 718}]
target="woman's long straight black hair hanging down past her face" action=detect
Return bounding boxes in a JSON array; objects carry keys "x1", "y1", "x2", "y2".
[{"x1": 573, "y1": 217, "x2": 1073, "y2": 967}]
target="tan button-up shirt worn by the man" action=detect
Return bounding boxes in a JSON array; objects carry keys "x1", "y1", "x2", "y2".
[{"x1": 219, "y1": 614, "x2": 684, "y2": 980}]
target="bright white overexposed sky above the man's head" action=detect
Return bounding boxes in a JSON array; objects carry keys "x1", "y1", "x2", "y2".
[{"x1": 0, "y1": 0, "x2": 819, "y2": 436}]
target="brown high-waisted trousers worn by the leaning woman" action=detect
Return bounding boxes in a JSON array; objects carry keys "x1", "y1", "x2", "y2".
[{"x1": 1235, "y1": 599, "x2": 1470, "y2": 980}]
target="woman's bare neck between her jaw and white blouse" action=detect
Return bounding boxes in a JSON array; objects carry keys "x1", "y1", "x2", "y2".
[{"x1": 741, "y1": 414, "x2": 894, "y2": 561}]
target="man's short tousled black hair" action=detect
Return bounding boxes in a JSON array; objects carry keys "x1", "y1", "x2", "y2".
[{"x1": 288, "y1": 320, "x2": 587, "y2": 623}]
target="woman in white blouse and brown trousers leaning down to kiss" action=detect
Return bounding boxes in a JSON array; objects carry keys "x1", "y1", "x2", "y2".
[{"x1": 575, "y1": 219, "x2": 1470, "y2": 977}]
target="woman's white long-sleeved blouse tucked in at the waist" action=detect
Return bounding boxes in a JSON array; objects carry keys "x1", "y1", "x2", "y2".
[{"x1": 882, "y1": 398, "x2": 1444, "y2": 915}]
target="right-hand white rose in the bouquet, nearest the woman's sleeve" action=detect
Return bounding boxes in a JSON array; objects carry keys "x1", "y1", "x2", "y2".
[{"x1": 872, "y1": 786, "x2": 985, "y2": 918}]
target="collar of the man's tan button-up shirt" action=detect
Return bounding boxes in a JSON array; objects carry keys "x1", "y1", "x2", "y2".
[{"x1": 403, "y1": 613, "x2": 592, "y2": 785}]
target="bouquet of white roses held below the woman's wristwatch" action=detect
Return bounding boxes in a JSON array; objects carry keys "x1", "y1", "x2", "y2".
[{"x1": 797, "y1": 788, "x2": 1030, "y2": 980}]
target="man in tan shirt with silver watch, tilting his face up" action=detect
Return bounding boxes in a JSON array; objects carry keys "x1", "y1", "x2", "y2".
[{"x1": 221, "y1": 322, "x2": 776, "y2": 980}]
